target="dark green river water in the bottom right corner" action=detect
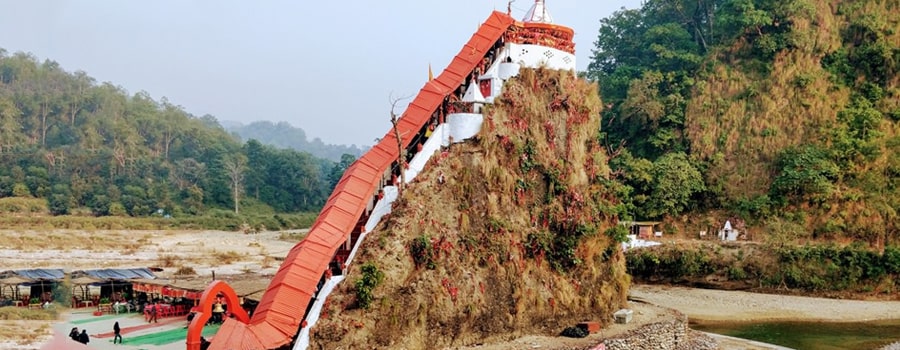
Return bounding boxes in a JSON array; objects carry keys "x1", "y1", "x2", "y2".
[{"x1": 691, "y1": 315, "x2": 900, "y2": 350}]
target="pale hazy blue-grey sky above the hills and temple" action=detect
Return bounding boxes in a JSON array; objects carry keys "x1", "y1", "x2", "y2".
[{"x1": 0, "y1": 0, "x2": 640, "y2": 145}]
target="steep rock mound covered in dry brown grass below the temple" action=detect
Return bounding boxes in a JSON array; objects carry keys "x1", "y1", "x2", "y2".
[{"x1": 312, "y1": 69, "x2": 630, "y2": 349}]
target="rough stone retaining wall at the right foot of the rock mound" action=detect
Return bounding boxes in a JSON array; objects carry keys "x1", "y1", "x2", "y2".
[{"x1": 603, "y1": 313, "x2": 719, "y2": 350}]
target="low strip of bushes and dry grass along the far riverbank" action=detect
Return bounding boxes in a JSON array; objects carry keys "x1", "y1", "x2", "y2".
[{"x1": 626, "y1": 241, "x2": 900, "y2": 300}]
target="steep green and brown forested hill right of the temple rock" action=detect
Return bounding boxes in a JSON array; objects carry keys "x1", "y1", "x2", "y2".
[{"x1": 586, "y1": 0, "x2": 900, "y2": 246}]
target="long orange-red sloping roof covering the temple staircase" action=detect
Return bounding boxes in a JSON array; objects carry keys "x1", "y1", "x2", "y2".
[{"x1": 210, "y1": 11, "x2": 514, "y2": 350}]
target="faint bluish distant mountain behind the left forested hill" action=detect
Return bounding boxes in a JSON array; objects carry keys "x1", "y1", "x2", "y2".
[{"x1": 227, "y1": 121, "x2": 363, "y2": 161}]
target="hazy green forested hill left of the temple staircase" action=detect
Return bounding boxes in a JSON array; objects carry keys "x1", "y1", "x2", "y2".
[{"x1": 0, "y1": 49, "x2": 352, "y2": 217}]
